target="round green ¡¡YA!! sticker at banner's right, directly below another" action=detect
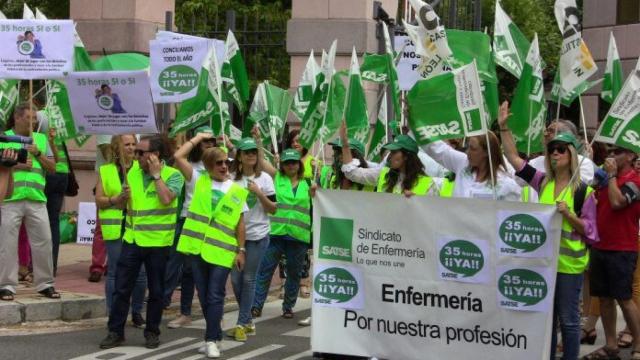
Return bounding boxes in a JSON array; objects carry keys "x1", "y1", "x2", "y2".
[{"x1": 498, "y1": 269, "x2": 548, "y2": 306}]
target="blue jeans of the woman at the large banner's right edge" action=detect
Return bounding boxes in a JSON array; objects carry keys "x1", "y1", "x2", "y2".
[{"x1": 550, "y1": 273, "x2": 583, "y2": 360}]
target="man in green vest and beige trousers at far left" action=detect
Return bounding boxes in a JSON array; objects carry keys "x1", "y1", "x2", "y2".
[{"x1": 0, "y1": 103, "x2": 60, "y2": 301}]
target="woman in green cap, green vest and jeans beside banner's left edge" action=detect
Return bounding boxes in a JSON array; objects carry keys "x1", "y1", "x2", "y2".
[{"x1": 251, "y1": 149, "x2": 317, "y2": 319}]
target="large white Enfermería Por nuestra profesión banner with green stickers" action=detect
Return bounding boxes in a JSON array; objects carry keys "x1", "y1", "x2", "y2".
[{"x1": 311, "y1": 191, "x2": 561, "y2": 359}]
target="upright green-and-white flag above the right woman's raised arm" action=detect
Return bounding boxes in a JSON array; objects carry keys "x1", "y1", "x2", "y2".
[{"x1": 509, "y1": 34, "x2": 546, "y2": 154}]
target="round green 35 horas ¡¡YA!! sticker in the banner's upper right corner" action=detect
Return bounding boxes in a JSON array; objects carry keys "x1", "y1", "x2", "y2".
[{"x1": 500, "y1": 214, "x2": 547, "y2": 252}]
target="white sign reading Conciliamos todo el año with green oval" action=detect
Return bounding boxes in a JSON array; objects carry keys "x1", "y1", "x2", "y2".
[{"x1": 149, "y1": 38, "x2": 209, "y2": 103}]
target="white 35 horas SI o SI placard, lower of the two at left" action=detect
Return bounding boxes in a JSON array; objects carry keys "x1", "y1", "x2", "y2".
[{"x1": 66, "y1": 71, "x2": 158, "y2": 135}]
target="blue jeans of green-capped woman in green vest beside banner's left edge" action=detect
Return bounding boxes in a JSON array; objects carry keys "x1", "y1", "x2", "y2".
[{"x1": 253, "y1": 235, "x2": 309, "y2": 311}]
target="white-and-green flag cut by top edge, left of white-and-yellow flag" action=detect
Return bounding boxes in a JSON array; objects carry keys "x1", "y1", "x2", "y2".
[{"x1": 493, "y1": 0, "x2": 530, "y2": 78}]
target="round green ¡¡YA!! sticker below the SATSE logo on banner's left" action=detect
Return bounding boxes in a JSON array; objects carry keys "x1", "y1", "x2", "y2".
[{"x1": 313, "y1": 267, "x2": 358, "y2": 303}]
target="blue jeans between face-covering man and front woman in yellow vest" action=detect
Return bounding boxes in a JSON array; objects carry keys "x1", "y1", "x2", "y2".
[{"x1": 164, "y1": 218, "x2": 195, "y2": 316}]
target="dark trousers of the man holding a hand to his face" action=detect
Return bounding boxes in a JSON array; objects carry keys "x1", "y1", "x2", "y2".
[{"x1": 108, "y1": 242, "x2": 169, "y2": 336}]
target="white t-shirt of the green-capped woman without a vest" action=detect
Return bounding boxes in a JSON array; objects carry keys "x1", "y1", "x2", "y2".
[{"x1": 231, "y1": 171, "x2": 276, "y2": 241}]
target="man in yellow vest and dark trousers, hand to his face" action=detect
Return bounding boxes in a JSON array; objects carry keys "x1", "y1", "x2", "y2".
[{"x1": 100, "y1": 135, "x2": 184, "y2": 349}]
